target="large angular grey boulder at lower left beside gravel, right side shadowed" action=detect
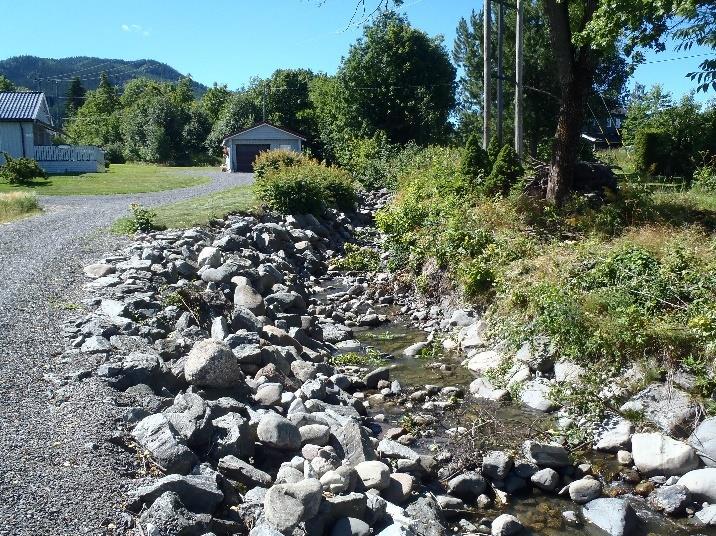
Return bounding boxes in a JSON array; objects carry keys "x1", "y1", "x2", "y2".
[{"x1": 132, "y1": 413, "x2": 198, "y2": 474}]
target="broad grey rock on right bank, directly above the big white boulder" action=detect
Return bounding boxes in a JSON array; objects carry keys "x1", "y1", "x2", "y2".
[{"x1": 619, "y1": 383, "x2": 700, "y2": 437}]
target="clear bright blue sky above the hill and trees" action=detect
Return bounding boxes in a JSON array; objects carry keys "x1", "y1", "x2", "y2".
[{"x1": 0, "y1": 0, "x2": 713, "y2": 99}]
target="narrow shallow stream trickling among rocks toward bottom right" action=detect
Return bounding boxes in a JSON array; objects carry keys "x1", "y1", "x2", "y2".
[{"x1": 314, "y1": 273, "x2": 716, "y2": 536}]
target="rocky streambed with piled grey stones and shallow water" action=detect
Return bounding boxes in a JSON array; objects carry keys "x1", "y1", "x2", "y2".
[{"x1": 61, "y1": 193, "x2": 716, "y2": 536}]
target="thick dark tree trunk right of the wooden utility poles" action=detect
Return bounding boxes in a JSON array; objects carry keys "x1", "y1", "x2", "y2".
[{"x1": 543, "y1": 0, "x2": 598, "y2": 205}]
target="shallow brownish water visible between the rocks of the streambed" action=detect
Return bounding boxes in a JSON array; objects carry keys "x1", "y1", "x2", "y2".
[{"x1": 316, "y1": 281, "x2": 716, "y2": 536}]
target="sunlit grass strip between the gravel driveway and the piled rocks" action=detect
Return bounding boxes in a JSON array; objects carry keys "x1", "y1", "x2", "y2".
[{"x1": 112, "y1": 186, "x2": 256, "y2": 234}]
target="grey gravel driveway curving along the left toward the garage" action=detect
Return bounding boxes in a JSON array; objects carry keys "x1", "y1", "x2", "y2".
[{"x1": 0, "y1": 172, "x2": 253, "y2": 536}]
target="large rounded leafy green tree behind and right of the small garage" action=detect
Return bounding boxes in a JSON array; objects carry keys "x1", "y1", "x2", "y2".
[{"x1": 337, "y1": 12, "x2": 456, "y2": 144}]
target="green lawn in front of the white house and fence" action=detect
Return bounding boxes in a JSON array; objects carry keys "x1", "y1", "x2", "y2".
[{"x1": 0, "y1": 164, "x2": 211, "y2": 195}]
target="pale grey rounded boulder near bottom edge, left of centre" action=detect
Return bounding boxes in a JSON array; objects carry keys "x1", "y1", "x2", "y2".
[{"x1": 264, "y1": 478, "x2": 323, "y2": 532}]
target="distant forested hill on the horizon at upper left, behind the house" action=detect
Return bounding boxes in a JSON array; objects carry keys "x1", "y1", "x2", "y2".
[{"x1": 0, "y1": 56, "x2": 207, "y2": 124}]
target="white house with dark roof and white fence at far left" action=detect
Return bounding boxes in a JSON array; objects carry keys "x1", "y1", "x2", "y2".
[{"x1": 0, "y1": 91, "x2": 104, "y2": 173}]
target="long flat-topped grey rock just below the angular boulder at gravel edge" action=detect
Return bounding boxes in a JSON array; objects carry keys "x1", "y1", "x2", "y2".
[{"x1": 130, "y1": 467, "x2": 224, "y2": 514}]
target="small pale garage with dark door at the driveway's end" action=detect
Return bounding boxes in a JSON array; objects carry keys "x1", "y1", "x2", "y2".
[{"x1": 222, "y1": 122, "x2": 306, "y2": 172}]
